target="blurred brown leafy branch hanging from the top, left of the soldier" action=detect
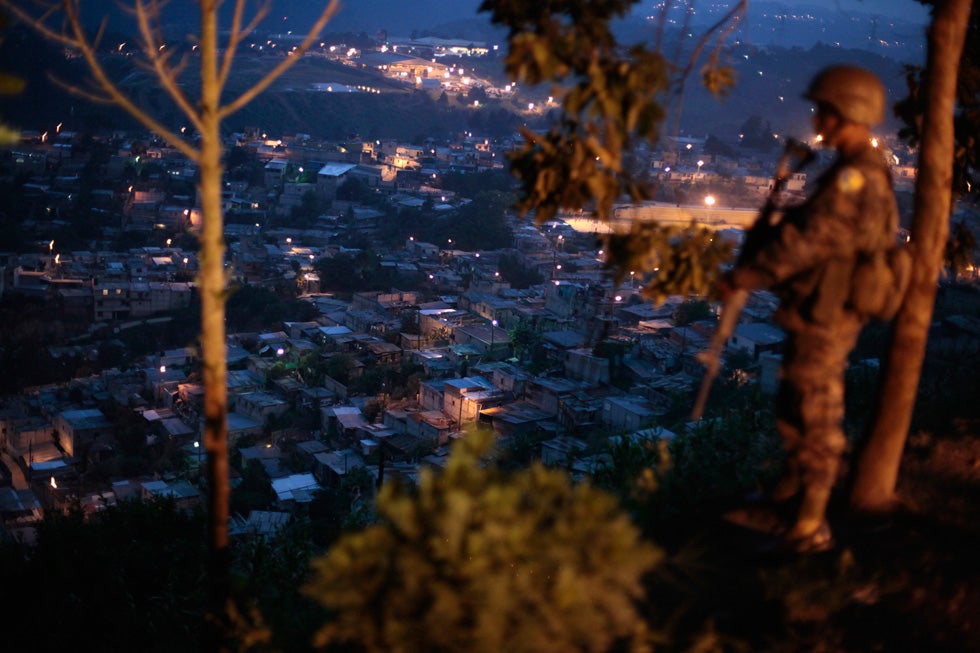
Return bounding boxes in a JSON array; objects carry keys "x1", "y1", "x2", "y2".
[{"x1": 480, "y1": 0, "x2": 747, "y2": 301}]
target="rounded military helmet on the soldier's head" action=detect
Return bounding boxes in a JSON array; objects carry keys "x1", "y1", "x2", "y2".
[{"x1": 804, "y1": 65, "x2": 885, "y2": 127}]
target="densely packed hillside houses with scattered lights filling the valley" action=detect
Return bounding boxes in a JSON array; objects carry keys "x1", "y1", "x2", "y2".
[{"x1": 0, "y1": 114, "x2": 980, "y2": 539}]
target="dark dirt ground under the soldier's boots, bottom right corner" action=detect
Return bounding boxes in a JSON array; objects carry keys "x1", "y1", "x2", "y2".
[{"x1": 651, "y1": 422, "x2": 980, "y2": 653}]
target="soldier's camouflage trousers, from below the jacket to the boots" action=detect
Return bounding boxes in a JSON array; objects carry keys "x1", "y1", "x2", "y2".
[{"x1": 776, "y1": 315, "x2": 862, "y2": 491}]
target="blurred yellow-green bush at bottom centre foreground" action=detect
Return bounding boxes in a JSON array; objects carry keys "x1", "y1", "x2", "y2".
[{"x1": 306, "y1": 434, "x2": 660, "y2": 652}]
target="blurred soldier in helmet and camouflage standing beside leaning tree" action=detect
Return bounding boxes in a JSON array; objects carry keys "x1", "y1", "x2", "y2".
[{"x1": 721, "y1": 65, "x2": 898, "y2": 552}]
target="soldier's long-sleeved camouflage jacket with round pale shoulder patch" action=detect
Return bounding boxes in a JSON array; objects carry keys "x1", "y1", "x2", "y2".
[{"x1": 732, "y1": 143, "x2": 898, "y2": 329}]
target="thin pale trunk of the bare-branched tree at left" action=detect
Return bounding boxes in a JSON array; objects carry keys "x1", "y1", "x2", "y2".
[{"x1": 199, "y1": 0, "x2": 230, "y2": 636}]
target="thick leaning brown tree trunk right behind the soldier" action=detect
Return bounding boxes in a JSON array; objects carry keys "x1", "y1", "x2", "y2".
[{"x1": 851, "y1": 0, "x2": 972, "y2": 512}]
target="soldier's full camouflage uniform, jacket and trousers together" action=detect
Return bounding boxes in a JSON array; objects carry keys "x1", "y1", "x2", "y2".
[{"x1": 731, "y1": 143, "x2": 898, "y2": 510}]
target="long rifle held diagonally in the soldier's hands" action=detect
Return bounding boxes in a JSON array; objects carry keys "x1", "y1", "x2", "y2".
[{"x1": 691, "y1": 138, "x2": 816, "y2": 422}]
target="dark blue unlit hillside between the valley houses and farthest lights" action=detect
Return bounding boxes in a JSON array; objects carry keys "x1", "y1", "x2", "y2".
[{"x1": 0, "y1": 25, "x2": 920, "y2": 140}]
